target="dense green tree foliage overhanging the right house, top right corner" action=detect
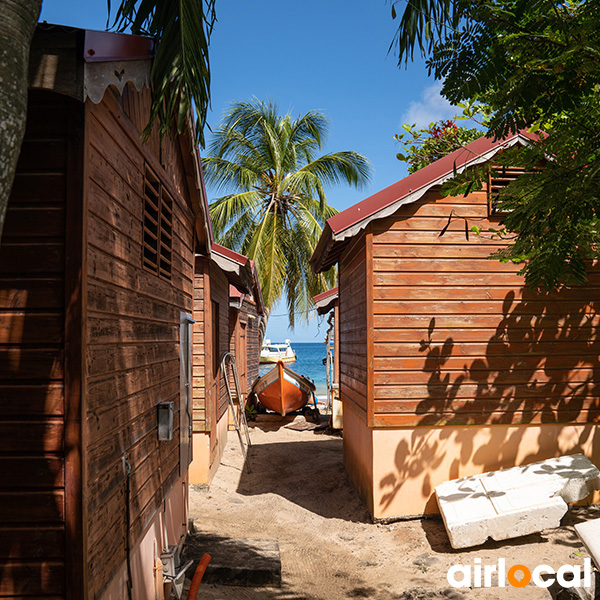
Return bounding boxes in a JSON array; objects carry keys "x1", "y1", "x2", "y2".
[{"x1": 396, "y1": 0, "x2": 600, "y2": 288}]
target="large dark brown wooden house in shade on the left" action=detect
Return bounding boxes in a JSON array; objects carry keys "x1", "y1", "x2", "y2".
[{"x1": 0, "y1": 25, "x2": 213, "y2": 600}]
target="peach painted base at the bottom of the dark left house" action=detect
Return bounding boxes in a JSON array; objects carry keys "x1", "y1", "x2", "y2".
[{"x1": 99, "y1": 475, "x2": 188, "y2": 600}]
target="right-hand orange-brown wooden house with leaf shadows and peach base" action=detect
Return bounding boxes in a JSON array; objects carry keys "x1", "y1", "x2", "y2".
[{"x1": 311, "y1": 133, "x2": 600, "y2": 519}]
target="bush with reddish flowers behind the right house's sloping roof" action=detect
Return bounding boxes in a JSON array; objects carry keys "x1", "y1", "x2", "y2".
[{"x1": 394, "y1": 120, "x2": 482, "y2": 173}]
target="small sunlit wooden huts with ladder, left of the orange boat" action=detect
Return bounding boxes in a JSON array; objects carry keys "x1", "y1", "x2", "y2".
[{"x1": 190, "y1": 242, "x2": 264, "y2": 485}]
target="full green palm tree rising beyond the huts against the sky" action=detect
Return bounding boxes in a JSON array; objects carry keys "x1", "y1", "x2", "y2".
[{"x1": 202, "y1": 100, "x2": 370, "y2": 333}]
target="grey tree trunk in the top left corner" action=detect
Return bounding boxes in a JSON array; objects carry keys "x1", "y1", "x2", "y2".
[{"x1": 0, "y1": 0, "x2": 42, "y2": 239}]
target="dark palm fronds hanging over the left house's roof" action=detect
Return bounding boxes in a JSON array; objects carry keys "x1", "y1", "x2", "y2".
[{"x1": 108, "y1": 0, "x2": 215, "y2": 145}]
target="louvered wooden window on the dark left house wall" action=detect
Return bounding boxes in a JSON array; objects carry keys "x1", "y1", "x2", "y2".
[{"x1": 143, "y1": 167, "x2": 173, "y2": 281}]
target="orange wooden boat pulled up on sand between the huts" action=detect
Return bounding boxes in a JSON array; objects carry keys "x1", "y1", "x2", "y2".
[{"x1": 252, "y1": 361, "x2": 316, "y2": 417}]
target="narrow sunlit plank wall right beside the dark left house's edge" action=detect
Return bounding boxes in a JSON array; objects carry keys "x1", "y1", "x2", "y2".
[{"x1": 192, "y1": 256, "x2": 211, "y2": 433}]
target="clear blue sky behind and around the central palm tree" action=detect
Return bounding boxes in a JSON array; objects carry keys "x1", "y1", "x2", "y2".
[{"x1": 40, "y1": 0, "x2": 455, "y2": 341}]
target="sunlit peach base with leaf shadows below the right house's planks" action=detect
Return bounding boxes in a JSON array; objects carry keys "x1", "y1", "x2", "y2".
[{"x1": 370, "y1": 424, "x2": 600, "y2": 519}]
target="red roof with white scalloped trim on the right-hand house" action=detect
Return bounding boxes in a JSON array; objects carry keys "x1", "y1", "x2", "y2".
[{"x1": 310, "y1": 130, "x2": 538, "y2": 272}]
